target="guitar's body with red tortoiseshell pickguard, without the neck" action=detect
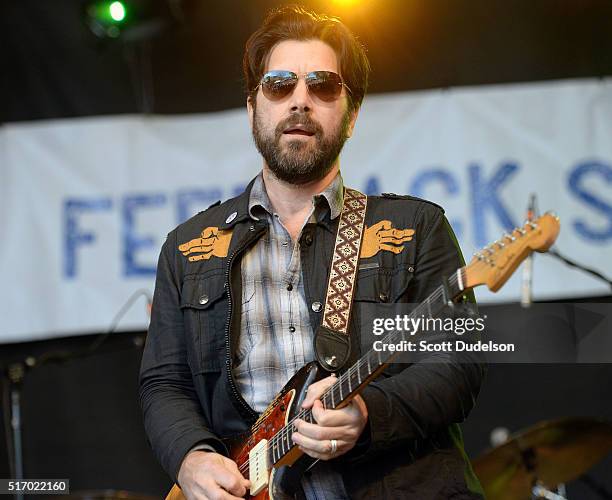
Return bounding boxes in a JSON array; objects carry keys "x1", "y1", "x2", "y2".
[{"x1": 166, "y1": 362, "x2": 325, "y2": 500}]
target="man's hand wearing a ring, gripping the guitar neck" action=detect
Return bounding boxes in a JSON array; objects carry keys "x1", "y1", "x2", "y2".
[{"x1": 293, "y1": 376, "x2": 368, "y2": 460}]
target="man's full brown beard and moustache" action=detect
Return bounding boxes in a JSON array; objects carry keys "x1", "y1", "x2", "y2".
[{"x1": 253, "y1": 110, "x2": 350, "y2": 185}]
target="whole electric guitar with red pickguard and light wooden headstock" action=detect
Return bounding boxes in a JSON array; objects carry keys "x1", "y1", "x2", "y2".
[{"x1": 166, "y1": 213, "x2": 559, "y2": 500}]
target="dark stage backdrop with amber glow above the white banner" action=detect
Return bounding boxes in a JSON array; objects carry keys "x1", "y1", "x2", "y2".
[{"x1": 0, "y1": 0, "x2": 612, "y2": 121}]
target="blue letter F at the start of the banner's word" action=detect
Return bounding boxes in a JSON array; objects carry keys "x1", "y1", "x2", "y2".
[{"x1": 64, "y1": 198, "x2": 112, "y2": 279}]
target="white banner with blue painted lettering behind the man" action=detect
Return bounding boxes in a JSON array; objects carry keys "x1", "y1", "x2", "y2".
[{"x1": 0, "y1": 80, "x2": 612, "y2": 342}]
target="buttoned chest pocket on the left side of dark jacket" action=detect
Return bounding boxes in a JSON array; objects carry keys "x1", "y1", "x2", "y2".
[{"x1": 181, "y1": 270, "x2": 228, "y2": 373}]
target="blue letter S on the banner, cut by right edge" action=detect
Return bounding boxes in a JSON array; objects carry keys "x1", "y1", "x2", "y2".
[{"x1": 568, "y1": 161, "x2": 612, "y2": 243}]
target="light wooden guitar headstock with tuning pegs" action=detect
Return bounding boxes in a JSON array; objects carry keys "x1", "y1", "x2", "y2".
[{"x1": 464, "y1": 212, "x2": 560, "y2": 292}]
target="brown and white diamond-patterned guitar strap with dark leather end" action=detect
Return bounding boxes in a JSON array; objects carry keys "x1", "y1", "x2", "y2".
[{"x1": 314, "y1": 188, "x2": 368, "y2": 372}]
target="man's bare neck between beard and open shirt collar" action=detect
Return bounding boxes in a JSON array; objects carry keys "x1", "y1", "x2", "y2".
[{"x1": 263, "y1": 160, "x2": 340, "y2": 221}]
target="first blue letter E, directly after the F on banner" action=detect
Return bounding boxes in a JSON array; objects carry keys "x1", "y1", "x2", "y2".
[{"x1": 122, "y1": 194, "x2": 166, "y2": 276}]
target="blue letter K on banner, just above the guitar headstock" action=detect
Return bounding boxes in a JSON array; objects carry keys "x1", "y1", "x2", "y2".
[{"x1": 468, "y1": 163, "x2": 519, "y2": 246}]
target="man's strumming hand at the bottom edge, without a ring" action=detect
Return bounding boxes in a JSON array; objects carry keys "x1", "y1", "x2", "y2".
[{"x1": 178, "y1": 451, "x2": 250, "y2": 500}]
